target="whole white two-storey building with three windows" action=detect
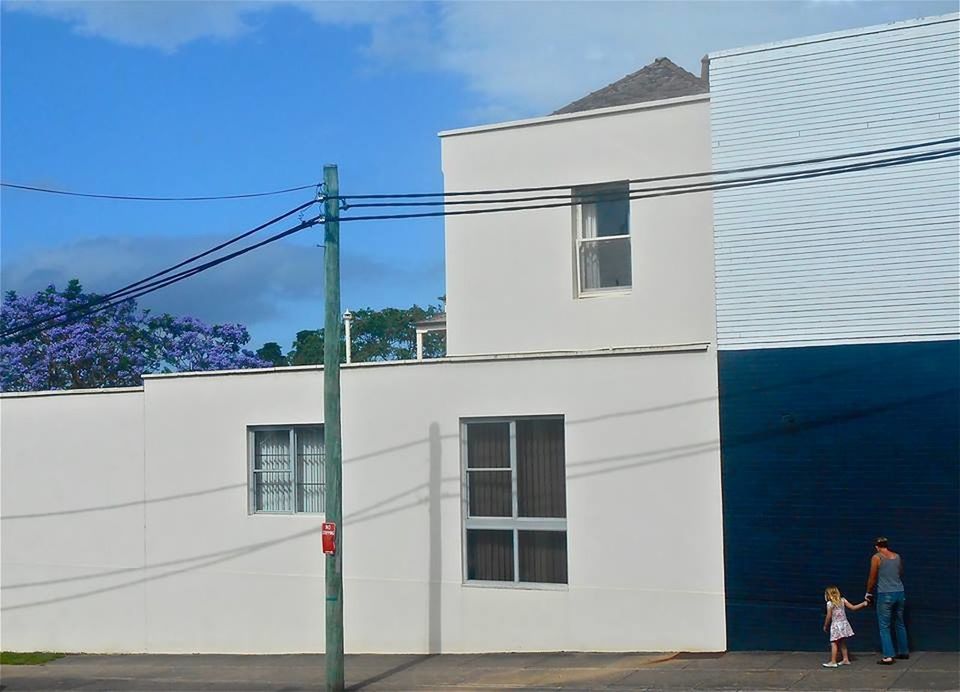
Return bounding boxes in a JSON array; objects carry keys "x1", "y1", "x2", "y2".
[{"x1": 0, "y1": 61, "x2": 726, "y2": 653}]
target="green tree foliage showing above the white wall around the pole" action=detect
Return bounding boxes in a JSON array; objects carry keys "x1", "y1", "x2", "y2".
[{"x1": 282, "y1": 298, "x2": 446, "y2": 365}]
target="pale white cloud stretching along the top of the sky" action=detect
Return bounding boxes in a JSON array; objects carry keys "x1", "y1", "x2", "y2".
[{"x1": 4, "y1": 0, "x2": 955, "y2": 116}]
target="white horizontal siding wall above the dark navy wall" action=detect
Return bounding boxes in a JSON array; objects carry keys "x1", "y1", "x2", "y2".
[{"x1": 710, "y1": 15, "x2": 960, "y2": 349}]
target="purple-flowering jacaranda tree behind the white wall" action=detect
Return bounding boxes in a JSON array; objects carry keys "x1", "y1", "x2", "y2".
[{"x1": 0, "y1": 279, "x2": 270, "y2": 391}]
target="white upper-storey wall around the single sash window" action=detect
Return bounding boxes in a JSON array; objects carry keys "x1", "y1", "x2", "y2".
[{"x1": 441, "y1": 96, "x2": 714, "y2": 355}]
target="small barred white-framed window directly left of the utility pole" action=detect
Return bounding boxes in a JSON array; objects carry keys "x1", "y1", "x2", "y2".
[{"x1": 248, "y1": 425, "x2": 324, "y2": 514}]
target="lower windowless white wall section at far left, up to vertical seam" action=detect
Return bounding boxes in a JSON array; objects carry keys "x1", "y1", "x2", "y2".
[{"x1": 0, "y1": 390, "x2": 146, "y2": 651}]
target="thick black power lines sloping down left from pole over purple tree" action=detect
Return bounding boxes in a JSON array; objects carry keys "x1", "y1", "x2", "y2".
[{"x1": 0, "y1": 200, "x2": 320, "y2": 339}]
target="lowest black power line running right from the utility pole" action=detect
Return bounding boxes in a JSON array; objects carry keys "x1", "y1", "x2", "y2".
[{"x1": 340, "y1": 148, "x2": 960, "y2": 222}]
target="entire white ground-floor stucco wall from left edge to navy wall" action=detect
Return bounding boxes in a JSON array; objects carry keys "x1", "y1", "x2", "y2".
[{"x1": 0, "y1": 350, "x2": 725, "y2": 653}]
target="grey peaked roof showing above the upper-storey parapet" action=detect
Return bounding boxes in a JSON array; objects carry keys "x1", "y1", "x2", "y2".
[{"x1": 553, "y1": 58, "x2": 710, "y2": 115}]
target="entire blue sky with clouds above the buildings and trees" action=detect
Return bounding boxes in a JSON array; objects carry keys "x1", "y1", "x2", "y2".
[{"x1": 0, "y1": 0, "x2": 957, "y2": 348}]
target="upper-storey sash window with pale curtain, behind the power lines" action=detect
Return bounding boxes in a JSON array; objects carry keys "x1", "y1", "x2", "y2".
[{"x1": 574, "y1": 183, "x2": 632, "y2": 295}]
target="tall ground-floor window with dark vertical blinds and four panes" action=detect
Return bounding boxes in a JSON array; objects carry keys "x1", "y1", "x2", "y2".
[{"x1": 461, "y1": 417, "x2": 567, "y2": 584}]
